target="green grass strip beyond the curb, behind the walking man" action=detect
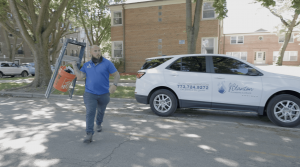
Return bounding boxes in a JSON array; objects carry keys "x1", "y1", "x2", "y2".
[{"x1": 0, "y1": 83, "x2": 135, "y2": 98}]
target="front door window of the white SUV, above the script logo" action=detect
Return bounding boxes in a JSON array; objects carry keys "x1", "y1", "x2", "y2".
[{"x1": 213, "y1": 56, "x2": 258, "y2": 75}]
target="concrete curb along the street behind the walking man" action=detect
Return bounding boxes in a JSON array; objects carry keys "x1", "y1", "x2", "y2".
[{"x1": 0, "y1": 91, "x2": 137, "y2": 103}]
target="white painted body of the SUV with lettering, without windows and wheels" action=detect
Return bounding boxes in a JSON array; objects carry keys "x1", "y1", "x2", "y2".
[{"x1": 135, "y1": 54, "x2": 300, "y2": 126}]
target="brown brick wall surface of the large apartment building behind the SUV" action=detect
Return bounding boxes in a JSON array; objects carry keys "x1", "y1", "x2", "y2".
[{"x1": 111, "y1": 3, "x2": 219, "y2": 73}]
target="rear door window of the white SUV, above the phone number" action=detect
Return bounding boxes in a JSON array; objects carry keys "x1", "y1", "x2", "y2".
[{"x1": 181, "y1": 56, "x2": 206, "y2": 72}]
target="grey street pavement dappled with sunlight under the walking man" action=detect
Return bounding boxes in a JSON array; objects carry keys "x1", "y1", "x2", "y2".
[{"x1": 0, "y1": 96, "x2": 300, "y2": 167}]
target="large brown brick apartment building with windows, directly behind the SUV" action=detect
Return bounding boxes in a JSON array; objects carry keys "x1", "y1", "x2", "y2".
[{"x1": 109, "y1": 0, "x2": 223, "y2": 73}]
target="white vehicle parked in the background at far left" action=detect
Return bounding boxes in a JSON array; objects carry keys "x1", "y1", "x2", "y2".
[{"x1": 0, "y1": 61, "x2": 29, "y2": 78}]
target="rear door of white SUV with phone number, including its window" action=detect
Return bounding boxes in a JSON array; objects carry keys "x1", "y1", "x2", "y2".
[{"x1": 164, "y1": 56, "x2": 212, "y2": 108}]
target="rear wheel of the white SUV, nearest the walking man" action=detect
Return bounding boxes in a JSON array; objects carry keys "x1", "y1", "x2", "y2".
[{"x1": 150, "y1": 89, "x2": 177, "y2": 117}]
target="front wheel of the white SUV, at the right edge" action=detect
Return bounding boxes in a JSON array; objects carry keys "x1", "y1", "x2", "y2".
[{"x1": 267, "y1": 94, "x2": 300, "y2": 127}]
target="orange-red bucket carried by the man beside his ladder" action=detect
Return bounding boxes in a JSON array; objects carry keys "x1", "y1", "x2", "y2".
[{"x1": 53, "y1": 66, "x2": 76, "y2": 92}]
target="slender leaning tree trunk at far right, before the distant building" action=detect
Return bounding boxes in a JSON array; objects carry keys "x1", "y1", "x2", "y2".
[{"x1": 277, "y1": 13, "x2": 299, "y2": 66}]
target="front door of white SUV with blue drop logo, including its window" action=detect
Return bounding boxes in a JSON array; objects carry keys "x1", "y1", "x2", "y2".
[{"x1": 212, "y1": 56, "x2": 263, "y2": 110}]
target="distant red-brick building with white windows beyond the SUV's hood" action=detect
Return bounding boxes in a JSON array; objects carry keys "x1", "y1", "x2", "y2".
[{"x1": 221, "y1": 29, "x2": 300, "y2": 65}]
